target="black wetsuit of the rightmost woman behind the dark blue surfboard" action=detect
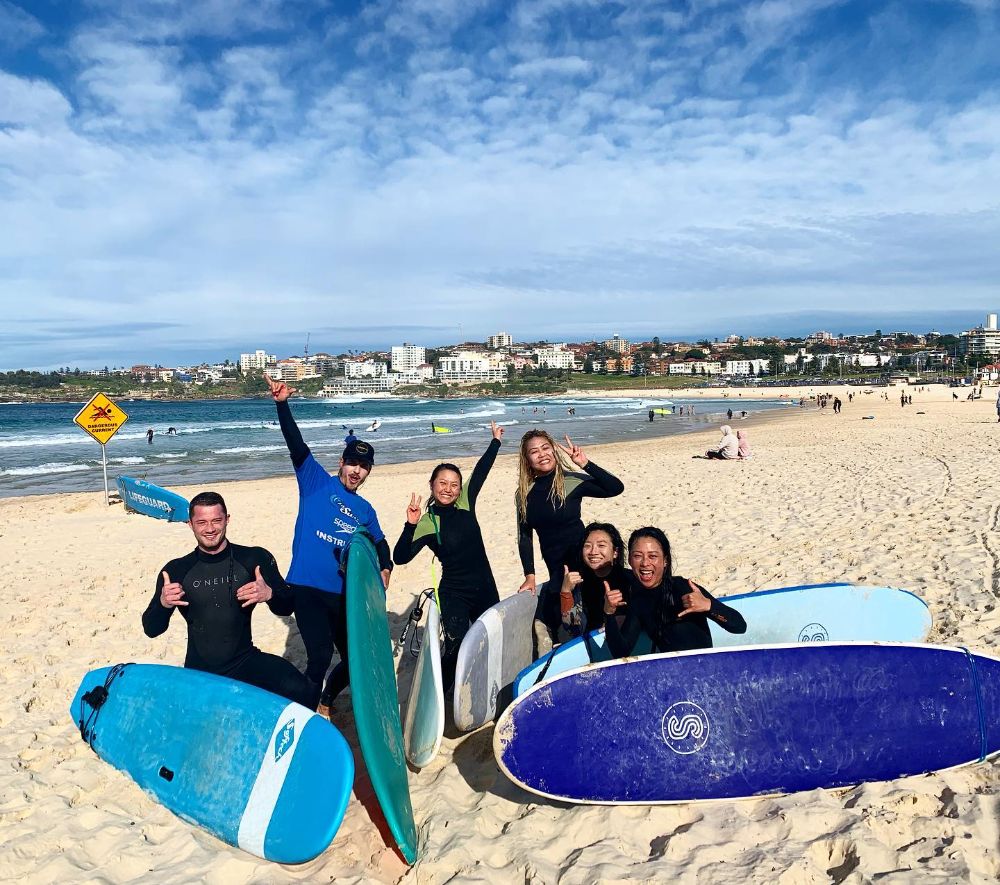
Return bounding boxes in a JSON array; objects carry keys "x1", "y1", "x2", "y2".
[{"x1": 604, "y1": 572, "x2": 747, "y2": 658}]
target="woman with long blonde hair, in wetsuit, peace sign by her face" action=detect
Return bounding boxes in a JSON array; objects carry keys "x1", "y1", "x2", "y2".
[{"x1": 516, "y1": 429, "x2": 625, "y2": 654}]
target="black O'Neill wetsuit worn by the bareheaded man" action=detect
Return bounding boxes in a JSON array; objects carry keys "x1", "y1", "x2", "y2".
[{"x1": 142, "y1": 542, "x2": 312, "y2": 704}]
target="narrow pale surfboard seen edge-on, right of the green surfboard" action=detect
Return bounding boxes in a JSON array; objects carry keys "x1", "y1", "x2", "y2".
[{"x1": 403, "y1": 599, "x2": 444, "y2": 768}]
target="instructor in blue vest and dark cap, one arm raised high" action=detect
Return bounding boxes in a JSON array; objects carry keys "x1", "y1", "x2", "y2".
[{"x1": 264, "y1": 375, "x2": 392, "y2": 715}]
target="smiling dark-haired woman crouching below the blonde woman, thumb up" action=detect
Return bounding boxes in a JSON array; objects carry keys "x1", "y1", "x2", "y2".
[{"x1": 559, "y1": 522, "x2": 627, "y2": 641}]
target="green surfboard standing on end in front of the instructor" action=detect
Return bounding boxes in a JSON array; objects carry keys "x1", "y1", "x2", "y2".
[{"x1": 345, "y1": 530, "x2": 417, "y2": 863}]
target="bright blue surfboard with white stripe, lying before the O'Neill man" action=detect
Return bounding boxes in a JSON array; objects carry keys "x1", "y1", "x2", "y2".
[{"x1": 70, "y1": 664, "x2": 354, "y2": 863}]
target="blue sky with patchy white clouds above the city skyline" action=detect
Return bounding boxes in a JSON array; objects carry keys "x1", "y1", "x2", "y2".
[{"x1": 0, "y1": 0, "x2": 1000, "y2": 369}]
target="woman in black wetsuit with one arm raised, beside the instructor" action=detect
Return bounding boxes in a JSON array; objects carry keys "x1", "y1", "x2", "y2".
[{"x1": 392, "y1": 421, "x2": 503, "y2": 691}]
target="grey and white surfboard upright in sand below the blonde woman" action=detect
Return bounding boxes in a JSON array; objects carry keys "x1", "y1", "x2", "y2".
[{"x1": 453, "y1": 593, "x2": 538, "y2": 731}]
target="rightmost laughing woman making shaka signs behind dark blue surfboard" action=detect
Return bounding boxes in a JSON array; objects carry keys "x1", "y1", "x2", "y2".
[{"x1": 604, "y1": 526, "x2": 747, "y2": 658}]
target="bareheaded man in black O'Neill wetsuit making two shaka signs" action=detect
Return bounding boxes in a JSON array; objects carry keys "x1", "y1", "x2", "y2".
[{"x1": 142, "y1": 492, "x2": 315, "y2": 705}]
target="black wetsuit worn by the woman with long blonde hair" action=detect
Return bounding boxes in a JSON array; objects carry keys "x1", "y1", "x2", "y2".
[{"x1": 517, "y1": 461, "x2": 625, "y2": 633}]
